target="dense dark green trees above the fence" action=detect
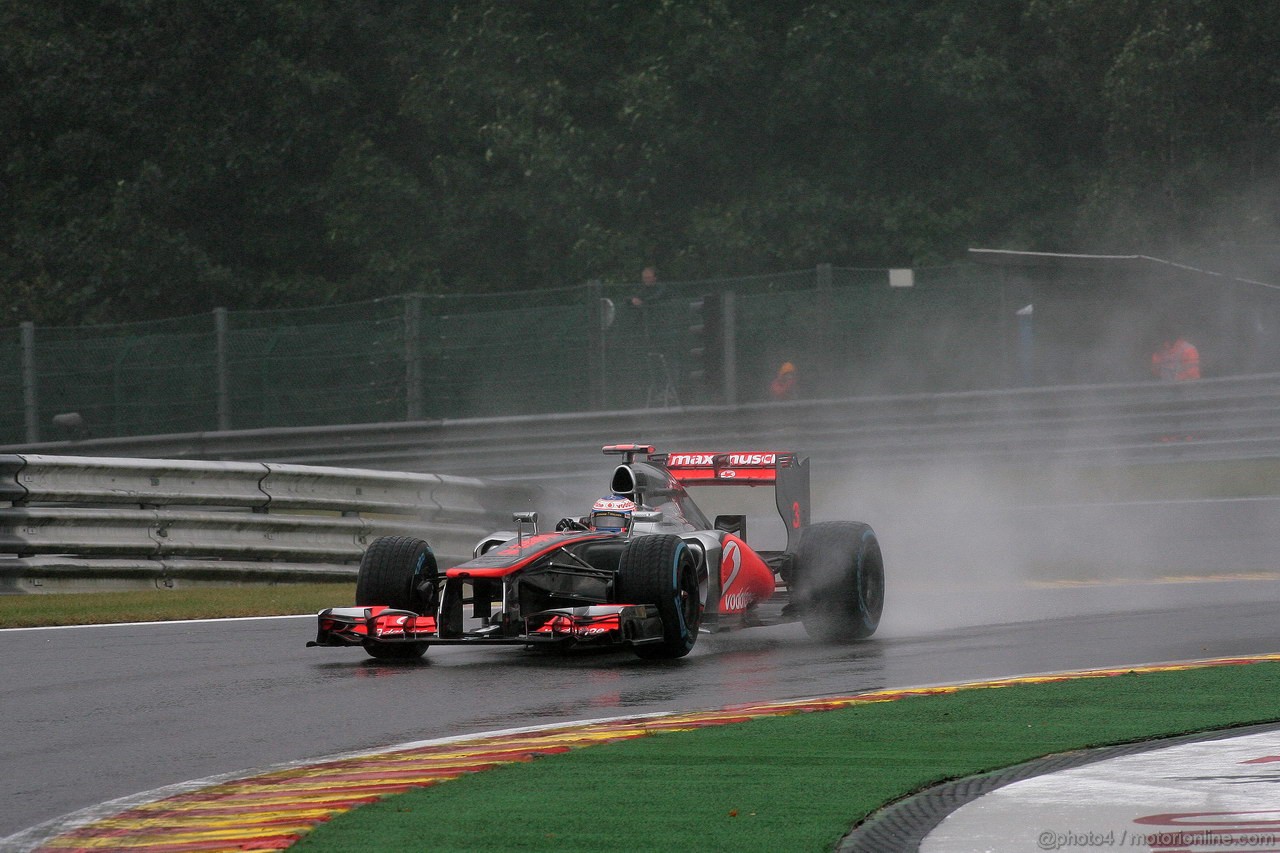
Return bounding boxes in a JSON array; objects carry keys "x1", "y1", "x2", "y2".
[{"x1": 0, "y1": 0, "x2": 1280, "y2": 325}]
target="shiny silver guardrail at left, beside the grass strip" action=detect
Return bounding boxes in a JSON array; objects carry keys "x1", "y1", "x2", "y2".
[{"x1": 0, "y1": 455, "x2": 538, "y2": 592}]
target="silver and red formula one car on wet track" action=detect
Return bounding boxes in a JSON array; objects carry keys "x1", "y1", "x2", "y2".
[{"x1": 308, "y1": 444, "x2": 884, "y2": 658}]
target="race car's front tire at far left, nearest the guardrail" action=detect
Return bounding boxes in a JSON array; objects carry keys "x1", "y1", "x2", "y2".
[{"x1": 356, "y1": 537, "x2": 439, "y2": 661}]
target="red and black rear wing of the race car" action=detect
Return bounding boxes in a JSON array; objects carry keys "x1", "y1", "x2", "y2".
[{"x1": 649, "y1": 451, "x2": 809, "y2": 549}]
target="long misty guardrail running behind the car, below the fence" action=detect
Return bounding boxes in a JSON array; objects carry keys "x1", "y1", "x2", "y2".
[{"x1": 0, "y1": 374, "x2": 1280, "y2": 480}]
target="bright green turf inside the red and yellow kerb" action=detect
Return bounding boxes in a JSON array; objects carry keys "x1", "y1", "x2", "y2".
[{"x1": 293, "y1": 663, "x2": 1280, "y2": 853}]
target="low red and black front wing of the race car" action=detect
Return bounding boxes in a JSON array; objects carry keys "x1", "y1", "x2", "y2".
[{"x1": 307, "y1": 605, "x2": 662, "y2": 646}]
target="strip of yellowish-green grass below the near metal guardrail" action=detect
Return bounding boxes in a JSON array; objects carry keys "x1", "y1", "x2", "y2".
[{"x1": 0, "y1": 583, "x2": 356, "y2": 628}]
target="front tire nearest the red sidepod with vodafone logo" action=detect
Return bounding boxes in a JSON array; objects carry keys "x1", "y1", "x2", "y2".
[{"x1": 614, "y1": 534, "x2": 703, "y2": 660}]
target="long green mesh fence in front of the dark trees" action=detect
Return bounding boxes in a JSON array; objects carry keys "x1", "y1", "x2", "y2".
[{"x1": 0, "y1": 258, "x2": 1280, "y2": 443}]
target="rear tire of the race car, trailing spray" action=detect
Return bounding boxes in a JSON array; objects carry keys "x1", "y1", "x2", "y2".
[{"x1": 791, "y1": 521, "x2": 884, "y2": 643}]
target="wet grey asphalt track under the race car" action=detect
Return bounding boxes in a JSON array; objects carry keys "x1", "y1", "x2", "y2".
[{"x1": 0, "y1": 580, "x2": 1280, "y2": 838}]
